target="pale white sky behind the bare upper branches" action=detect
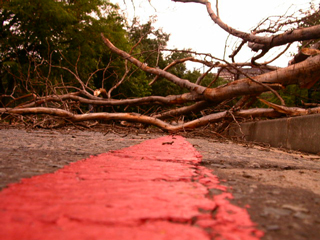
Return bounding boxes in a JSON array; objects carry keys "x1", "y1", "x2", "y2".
[{"x1": 111, "y1": 0, "x2": 320, "y2": 68}]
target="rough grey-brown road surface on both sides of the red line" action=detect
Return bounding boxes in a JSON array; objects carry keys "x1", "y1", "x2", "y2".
[{"x1": 0, "y1": 125, "x2": 320, "y2": 240}]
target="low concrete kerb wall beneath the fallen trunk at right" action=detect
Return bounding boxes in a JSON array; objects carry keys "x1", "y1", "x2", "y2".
[{"x1": 229, "y1": 114, "x2": 320, "y2": 153}]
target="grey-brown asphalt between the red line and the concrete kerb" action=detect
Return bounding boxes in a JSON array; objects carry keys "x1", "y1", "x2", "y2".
[{"x1": 188, "y1": 139, "x2": 320, "y2": 240}]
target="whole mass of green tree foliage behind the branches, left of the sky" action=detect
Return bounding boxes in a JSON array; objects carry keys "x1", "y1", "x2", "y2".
[{"x1": 0, "y1": 0, "x2": 228, "y2": 109}]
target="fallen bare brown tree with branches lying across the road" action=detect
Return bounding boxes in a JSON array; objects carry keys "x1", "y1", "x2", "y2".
[{"x1": 0, "y1": 0, "x2": 320, "y2": 132}]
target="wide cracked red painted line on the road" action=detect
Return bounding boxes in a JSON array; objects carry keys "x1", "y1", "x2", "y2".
[{"x1": 0, "y1": 136, "x2": 263, "y2": 240}]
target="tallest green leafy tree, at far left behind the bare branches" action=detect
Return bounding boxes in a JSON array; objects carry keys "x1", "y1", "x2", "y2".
[{"x1": 0, "y1": 0, "x2": 129, "y2": 97}]
